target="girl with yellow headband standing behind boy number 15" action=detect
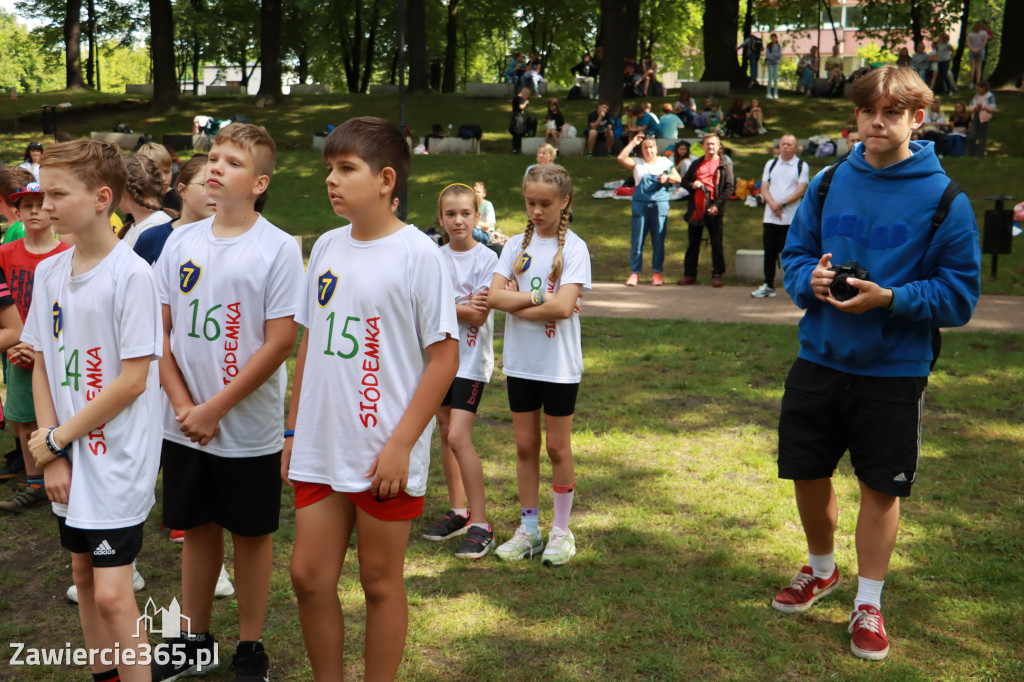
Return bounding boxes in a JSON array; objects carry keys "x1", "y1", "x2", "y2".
[{"x1": 423, "y1": 183, "x2": 498, "y2": 559}]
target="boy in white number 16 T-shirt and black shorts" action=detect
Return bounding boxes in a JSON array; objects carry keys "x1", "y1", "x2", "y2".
[{"x1": 154, "y1": 124, "x2": 303, "y2": 679}]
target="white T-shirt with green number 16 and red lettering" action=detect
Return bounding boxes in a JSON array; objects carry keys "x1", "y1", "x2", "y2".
[{"x1": 156, "y1": 216, "x2": 304, "y2": 458}]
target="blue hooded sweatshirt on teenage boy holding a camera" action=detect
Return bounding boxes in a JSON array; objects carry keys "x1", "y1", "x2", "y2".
[{"x1": 782, "y1": 141, "x2": 981, "y2": 377}]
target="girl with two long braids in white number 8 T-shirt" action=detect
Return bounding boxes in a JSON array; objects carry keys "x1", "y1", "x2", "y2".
[{"x1": 487, "y1": 164, "x2": 590, "y2": 566}]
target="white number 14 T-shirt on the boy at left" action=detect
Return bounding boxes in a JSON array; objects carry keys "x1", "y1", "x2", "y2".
[{"x1": 22, "y1": 243, "x2": 163, "y2": 530}]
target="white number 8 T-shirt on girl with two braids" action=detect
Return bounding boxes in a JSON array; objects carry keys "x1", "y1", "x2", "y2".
[{"x1": 495, "y1": 229, "x2": 590, "y2": 384}]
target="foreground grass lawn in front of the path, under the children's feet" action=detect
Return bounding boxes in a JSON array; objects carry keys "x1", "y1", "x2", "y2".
[{"x1": 0, "y1": 315, "x2": 1024, "y2": 681}]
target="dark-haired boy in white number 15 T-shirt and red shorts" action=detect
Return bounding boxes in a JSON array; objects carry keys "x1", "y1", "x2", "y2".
[{"x1": 282, "y1": 118, "x2": 459, "y2": 680}]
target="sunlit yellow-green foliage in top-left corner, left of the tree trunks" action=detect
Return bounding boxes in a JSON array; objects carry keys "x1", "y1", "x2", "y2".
[{"x1": 0, "y1": 8, "x2": 65, "y2": 96}]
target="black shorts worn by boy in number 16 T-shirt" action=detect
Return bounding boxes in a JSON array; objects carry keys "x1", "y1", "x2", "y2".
[{"x1": 161, "y1": 439, "x2": 282, "y2": 538}]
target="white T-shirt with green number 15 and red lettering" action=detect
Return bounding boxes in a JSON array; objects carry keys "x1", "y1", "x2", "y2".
[{"x1": 289, "y1": 225, "x2": 459, "y2": 497}]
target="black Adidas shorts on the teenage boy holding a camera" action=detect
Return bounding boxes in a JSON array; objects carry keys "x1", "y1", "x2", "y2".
[{"x1": 778, "y1": 358, "x2": 928, "y2": 498}]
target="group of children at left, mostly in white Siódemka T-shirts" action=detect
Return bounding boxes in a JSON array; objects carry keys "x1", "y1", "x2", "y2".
[{"x1": 0, "y1": 118, "x2": 590, "y2": 680}]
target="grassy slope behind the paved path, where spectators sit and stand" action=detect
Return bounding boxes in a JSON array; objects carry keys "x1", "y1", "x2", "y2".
[{"x1": 0, "y1": 90, "x2": 1024, "y2": 294}]
